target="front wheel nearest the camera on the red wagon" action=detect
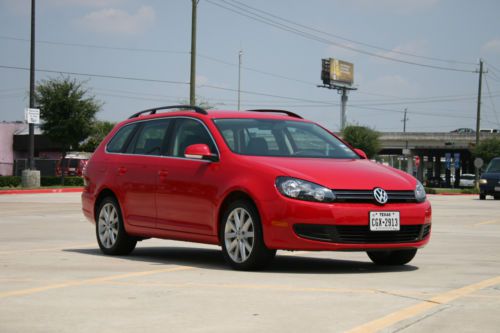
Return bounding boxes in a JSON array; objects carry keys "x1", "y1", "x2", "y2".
[{"x1": 220, "y1": 200, "x2": 276, "y2": 270}]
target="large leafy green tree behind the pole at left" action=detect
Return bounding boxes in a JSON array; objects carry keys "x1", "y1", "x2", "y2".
[{"x1": 35, "y1": 77, "x2": 102, "y2": 184}]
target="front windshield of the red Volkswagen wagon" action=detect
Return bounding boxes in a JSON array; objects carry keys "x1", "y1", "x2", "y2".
[{"x1": 214, "y1": 119, "x2": 359, "y2": 159}]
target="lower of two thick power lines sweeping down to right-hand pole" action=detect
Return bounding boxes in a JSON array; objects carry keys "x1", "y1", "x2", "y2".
[{"x1": 206, "y1": 0, "x2": 475, "y2": 73}]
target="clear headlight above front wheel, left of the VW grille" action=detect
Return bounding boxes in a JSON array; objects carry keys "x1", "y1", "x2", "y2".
[{"x1": 276, "y1": 177, "x2": 335, "y2": 202}]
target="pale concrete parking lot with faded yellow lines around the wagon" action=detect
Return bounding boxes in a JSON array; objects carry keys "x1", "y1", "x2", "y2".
[{"x1": 0, "y1": 193, "x2": 500, "y2": 332}]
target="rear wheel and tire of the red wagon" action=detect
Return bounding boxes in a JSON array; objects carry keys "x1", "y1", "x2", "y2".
[{"x1": 95, "y1": 197, "x2": 137, "y2": 255}]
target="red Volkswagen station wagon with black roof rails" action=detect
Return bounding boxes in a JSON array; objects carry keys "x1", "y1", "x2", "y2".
[{"x1": 82, "y1": 106, "x2": 431, "y2": 270}]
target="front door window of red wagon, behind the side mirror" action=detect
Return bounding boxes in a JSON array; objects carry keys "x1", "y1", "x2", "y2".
[{"x1": 172, "y1": 118, "x2": 217, "y2": 157}]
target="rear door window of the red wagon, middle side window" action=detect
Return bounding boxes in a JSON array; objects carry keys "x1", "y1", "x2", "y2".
[{"x1": 127, "y1": 119, "x2": 170, "y2": 155}]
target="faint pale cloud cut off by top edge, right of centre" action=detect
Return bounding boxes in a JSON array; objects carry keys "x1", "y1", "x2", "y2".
[{"x1": 350, "y1": 0, "x2": 440, "y2": 13}]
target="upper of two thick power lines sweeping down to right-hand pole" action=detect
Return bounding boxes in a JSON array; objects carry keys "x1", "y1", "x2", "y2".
[{"x1": 227, "y1": 0, "x2": 476, "y2": 65}]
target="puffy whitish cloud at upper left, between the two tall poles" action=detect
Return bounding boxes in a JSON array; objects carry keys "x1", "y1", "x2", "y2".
[{"x1": 73, "y1": 6, "x2": 156, "y2": 35}]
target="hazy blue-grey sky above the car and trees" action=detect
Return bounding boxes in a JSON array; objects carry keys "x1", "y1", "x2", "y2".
[{"x1": 0, "y1": 0, "x2": 500, "y2": 132}]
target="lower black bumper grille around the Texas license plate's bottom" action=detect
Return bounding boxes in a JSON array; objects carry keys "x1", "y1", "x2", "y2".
[{"x1": 293, "y1": 224, "x2": 431, "y2": 244}]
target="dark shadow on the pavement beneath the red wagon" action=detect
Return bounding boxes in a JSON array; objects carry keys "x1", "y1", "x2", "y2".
[{"x1": 63, "y1": 247, "x2": 418, "y2": 274}]
